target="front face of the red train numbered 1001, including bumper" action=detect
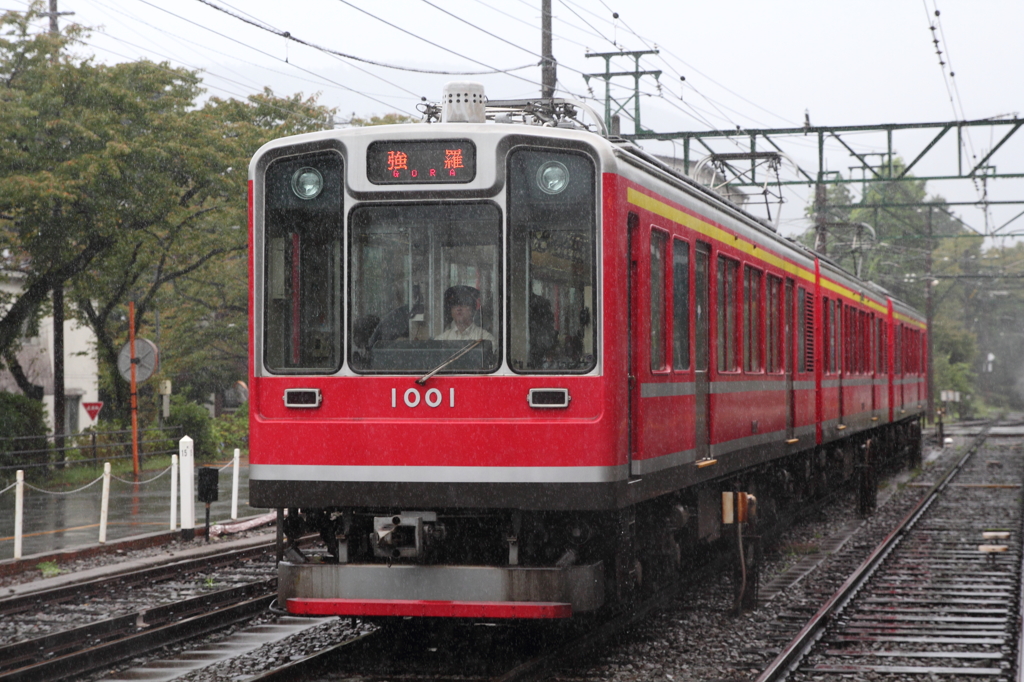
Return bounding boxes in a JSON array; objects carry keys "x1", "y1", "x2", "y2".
[{"x1": 250, "y1": 89, "x2": 628, "y2": 619}]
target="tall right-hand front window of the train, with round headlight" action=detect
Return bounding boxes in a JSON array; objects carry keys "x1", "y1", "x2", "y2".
[{"x1": 508, "y1": 147, "x2": 599, "y2": 374}]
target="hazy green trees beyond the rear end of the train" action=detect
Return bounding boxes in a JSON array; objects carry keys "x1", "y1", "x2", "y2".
[{"x1": 801, "y1": 159, "x2": 1024, "y2": 415}]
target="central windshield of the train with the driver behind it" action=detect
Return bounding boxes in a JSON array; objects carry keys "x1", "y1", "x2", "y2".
[{"x1": 348, "y1": 204, "x2": 502, "y2": 374}]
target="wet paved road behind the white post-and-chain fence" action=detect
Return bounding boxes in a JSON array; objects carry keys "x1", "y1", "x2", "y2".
[{"x1": 0, "y1": 459, "x2": 266, "y2": 560}]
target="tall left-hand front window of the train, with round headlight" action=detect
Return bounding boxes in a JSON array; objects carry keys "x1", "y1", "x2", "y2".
[{"x1": 263, "y1": 152, "x2": 343, "y2": 374}]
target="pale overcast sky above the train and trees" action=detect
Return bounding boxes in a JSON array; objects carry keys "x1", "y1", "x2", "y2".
[{"x1": 14, "y1": 0, "x2": 1024, "y2": 243}]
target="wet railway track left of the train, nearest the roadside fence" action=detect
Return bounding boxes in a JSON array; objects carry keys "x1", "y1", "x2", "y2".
[{"x1": 0, "y1": 544, "x2": 276, "y2": 681}]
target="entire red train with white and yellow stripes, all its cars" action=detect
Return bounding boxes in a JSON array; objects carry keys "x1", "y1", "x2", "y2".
[{"x1": 249, "y1": 84, "x2": 927, "y2": 619}]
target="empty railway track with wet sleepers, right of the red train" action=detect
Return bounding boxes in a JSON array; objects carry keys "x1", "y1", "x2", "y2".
[{"x1": 758, "y1": 421, "x2": 1024, "y2": 682}]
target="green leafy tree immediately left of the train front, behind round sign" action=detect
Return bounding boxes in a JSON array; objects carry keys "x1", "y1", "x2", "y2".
[{"x1": 76, "y1": 87, "x2": 333, "y2": 414}]
